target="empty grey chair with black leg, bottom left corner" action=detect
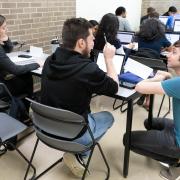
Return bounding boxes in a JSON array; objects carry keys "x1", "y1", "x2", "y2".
[{"x1": 0, "y1": 112, "x2": 36, "y2": 178}]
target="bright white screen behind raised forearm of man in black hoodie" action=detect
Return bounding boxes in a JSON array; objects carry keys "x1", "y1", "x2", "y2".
[{"x1": 97, "y1": 53, "x2": 124, "y2": 74}]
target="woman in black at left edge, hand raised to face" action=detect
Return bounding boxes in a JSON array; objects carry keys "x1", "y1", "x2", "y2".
[{"x1": 0, "y1": 15, "x2": 39, "y2": 120}]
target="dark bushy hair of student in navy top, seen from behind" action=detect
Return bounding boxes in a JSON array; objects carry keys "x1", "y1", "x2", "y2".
[{"x1": 137, "y1": 18, "x2": 165, "y2": 41}]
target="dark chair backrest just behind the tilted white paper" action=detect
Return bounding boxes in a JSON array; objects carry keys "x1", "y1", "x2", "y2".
[{"x1": 130, "y1": 56, "x2": 167, "y2": 71}]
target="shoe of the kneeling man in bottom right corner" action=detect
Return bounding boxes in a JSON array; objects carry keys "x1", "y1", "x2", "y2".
[{"x1": 160, "y1": 166, "x2": 180, "y2": 180}]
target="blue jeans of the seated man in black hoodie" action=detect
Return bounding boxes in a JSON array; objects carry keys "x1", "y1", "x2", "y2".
[{"x1": 74, "y1": 111, "x2": 114, "y2": 157}]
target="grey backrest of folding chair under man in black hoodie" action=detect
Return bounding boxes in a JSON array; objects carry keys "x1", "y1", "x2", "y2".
[{"x1": 30, "y1": 100, "x2": 86, "y2": 140}]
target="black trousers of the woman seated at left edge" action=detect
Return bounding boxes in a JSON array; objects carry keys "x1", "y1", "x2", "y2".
[{"x1": 4, "y1": 73, "x2": 33, "y2": 112}]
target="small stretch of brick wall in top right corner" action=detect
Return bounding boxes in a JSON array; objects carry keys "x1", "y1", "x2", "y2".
[{"x1": 142, "y1": 0, "x2": 180, "y2": 15}]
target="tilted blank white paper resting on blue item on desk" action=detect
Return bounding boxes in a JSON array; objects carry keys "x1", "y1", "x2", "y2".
[{"x1": 124, "y1": 58, "x2": 153, "y2": 79}]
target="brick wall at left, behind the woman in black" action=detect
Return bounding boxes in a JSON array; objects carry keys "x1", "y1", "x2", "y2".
[{"x1": 0, "y1": 0, "x2": 76, "y2": 52}]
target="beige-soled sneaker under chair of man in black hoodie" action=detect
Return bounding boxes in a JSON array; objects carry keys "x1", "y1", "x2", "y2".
[{"x1": 63, "y1": 153, "x2": 85, "y2": 177}]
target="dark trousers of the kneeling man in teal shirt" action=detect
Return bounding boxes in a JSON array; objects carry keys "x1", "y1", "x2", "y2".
[{"x1": 123, "y1": 118, "x2": 180, "y2": 165}]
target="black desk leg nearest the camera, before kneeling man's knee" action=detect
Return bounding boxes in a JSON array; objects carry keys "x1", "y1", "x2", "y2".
[{"x1": 123, "y1": 100, "x2": 133, "y2": 177}]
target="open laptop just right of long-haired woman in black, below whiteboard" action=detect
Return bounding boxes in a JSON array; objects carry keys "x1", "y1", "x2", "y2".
[{"x1": 117, "y1": 31, "x2": 135, "y2": 44}]
